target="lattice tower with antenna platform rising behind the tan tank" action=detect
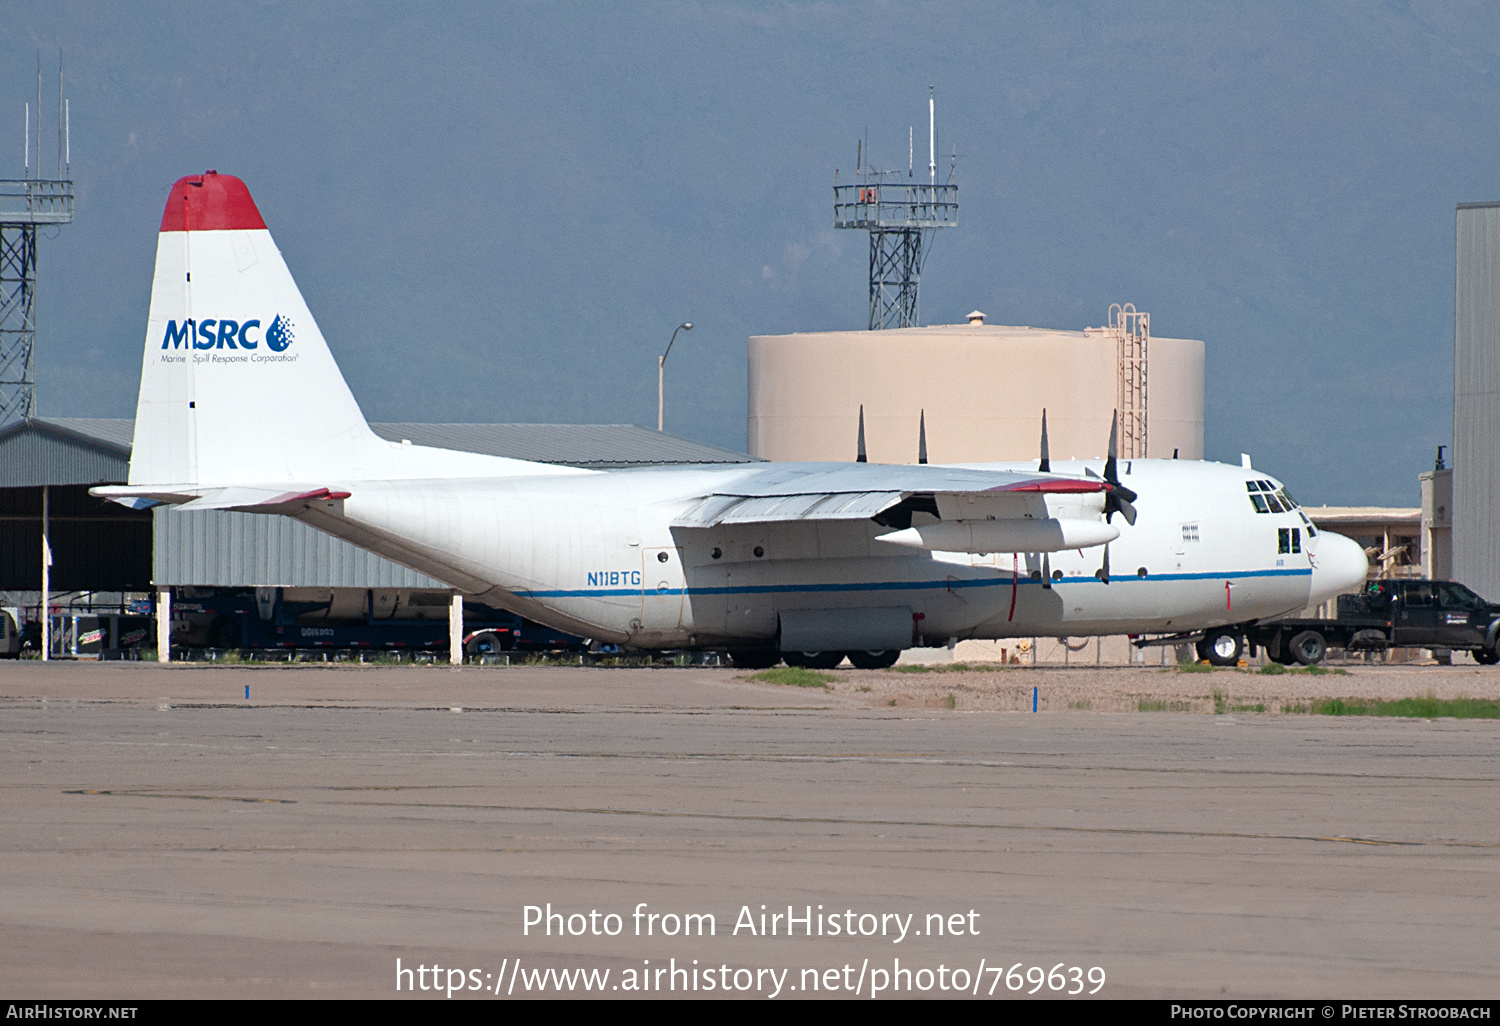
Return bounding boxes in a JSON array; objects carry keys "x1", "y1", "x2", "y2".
[{"x1": 834, "y1": 87, "x2": 959, "y2": 332}]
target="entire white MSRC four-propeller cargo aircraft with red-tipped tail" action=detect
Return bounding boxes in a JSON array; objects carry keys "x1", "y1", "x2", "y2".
[{"x1": 93, "y1": 171, "x2": 1367, "y2": 668}]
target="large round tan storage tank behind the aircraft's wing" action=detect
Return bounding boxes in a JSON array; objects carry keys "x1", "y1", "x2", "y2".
[{"x1": 747, "y1": 312, "x2": 1203, "y2": 464}]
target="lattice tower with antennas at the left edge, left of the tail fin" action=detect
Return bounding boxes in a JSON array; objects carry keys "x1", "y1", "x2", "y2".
[{"x1": 0, "y1": 56, "x2": 74, "y2": 425}]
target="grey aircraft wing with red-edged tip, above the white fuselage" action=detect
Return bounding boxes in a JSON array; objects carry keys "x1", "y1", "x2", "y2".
[{"x1": 672, "y1": 464, "x2": 1109, "y2": 528}]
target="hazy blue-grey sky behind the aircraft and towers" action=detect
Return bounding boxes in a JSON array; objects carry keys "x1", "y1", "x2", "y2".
[{"x1": 0, "y1": 0, "x2": 1500, "y2": 506}]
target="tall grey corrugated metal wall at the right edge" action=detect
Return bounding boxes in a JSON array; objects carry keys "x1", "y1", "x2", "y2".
[{"x1": 1454, "y1": 204, "x2": 1500, "y2": 602}]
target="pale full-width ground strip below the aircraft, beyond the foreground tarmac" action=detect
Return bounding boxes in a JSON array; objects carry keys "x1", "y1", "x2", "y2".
[{"x1": 0, "y1": 660, "x2": 1500, "y2": 716}]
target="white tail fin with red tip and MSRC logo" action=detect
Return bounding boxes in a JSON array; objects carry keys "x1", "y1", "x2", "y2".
[{"x1": 131, "y1": 171, "x2": 576, "y2": 495}]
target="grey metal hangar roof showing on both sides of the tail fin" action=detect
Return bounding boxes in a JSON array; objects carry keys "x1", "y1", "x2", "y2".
[{"x1": 0, "y1": 417, "x2": 755, "y2": 488}]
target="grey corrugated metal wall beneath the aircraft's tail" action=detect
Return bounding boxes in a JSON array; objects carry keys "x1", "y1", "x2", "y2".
[{"x1": 152, "y1": 507, "x2": 447, "y2": 588}]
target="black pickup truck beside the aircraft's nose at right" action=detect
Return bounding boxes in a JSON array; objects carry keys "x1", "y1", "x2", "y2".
[{"x1": 1137, "y1": 578, "x2": 1500, "y2": 666}]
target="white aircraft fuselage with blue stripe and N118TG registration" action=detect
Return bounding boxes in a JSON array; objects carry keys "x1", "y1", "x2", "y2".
[{"x1": 302, "y1": 459, "x2": 1365, "y2": 648}]
